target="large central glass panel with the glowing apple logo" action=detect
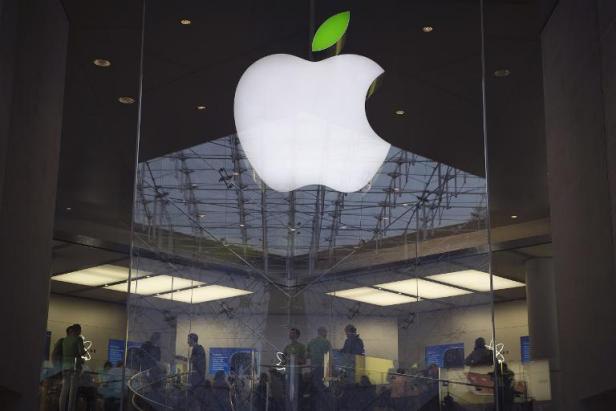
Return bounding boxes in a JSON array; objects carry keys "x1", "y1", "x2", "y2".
[{"x1": 125, "y1": 0, "x2": 506, "y2": 410}]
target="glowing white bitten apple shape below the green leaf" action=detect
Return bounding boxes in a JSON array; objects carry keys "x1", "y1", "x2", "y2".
[{"x1": 234, "y1": 54, "x2": 390, "y2": 193}]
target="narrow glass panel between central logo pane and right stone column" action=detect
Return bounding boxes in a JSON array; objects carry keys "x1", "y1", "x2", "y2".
[{"x1": 485, "y1": 2, "x2": 560, "y2": 409}]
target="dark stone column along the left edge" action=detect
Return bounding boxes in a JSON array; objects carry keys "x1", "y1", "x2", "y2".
[{"x1": 0, "y1": 0, "x2": 68, "y2": 411}]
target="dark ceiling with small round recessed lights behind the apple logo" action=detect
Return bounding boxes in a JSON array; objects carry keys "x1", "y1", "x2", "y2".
[{"x1": 56, "y1": 0, "x2": 550, "y2": 274}]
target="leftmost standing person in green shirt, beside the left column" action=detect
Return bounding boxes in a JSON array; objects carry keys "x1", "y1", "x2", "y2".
[{"x1": 60, "y1": 324, "x2": 86, "y2": 411}]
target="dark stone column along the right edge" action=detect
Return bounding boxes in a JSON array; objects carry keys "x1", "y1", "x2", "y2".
[{"x1": 542, "y1": 0, "x2": 616, "y2": 411}]
